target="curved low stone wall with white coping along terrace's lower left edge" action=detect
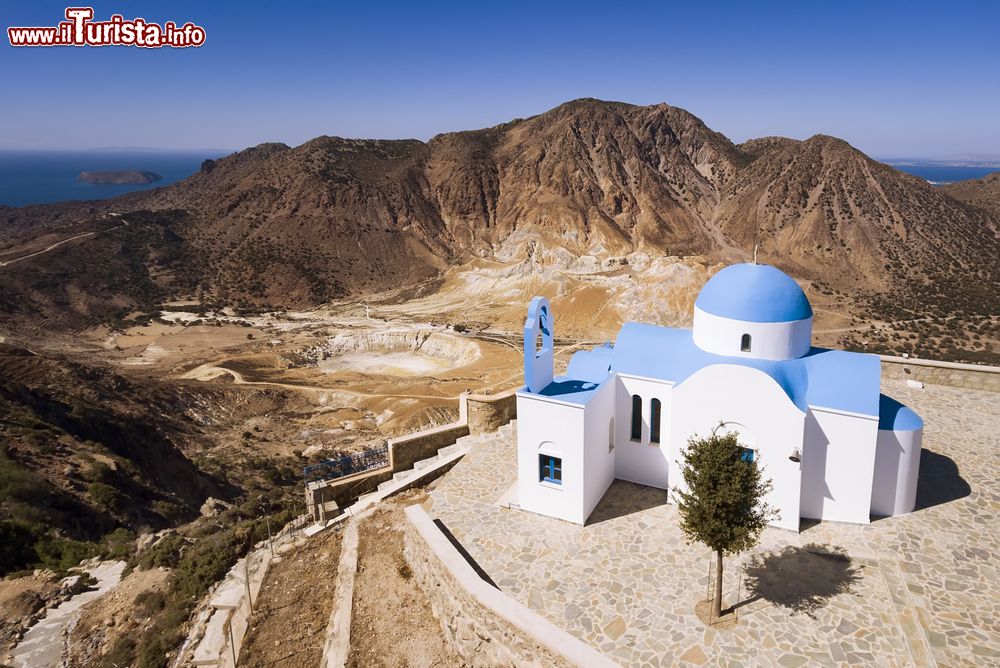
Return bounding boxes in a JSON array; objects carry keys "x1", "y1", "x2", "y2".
[{"x1": 403, "y1": 506, "x2": 617, "y2": 668}]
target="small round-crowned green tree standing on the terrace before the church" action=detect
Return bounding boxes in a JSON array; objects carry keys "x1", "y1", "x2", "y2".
[{"x1": 673, "y1": 433, "x2": 778, "y2": 619}]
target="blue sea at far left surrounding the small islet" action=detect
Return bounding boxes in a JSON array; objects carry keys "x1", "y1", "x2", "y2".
[{"x1": 0, "y1": 149, "x2": 230, "y2": 206}]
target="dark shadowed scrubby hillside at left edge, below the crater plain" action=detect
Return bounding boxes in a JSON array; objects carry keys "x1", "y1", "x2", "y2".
[{"x1": 0, "y1": 343, "x2": 225, "y2": 574}]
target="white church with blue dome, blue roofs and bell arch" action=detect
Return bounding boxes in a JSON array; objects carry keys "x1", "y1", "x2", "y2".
[{"x1": 517, "y1": 264, "x2": 923, "y2": 531}]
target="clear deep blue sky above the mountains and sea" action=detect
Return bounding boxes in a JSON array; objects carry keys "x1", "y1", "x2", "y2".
[{"x1": 0, "y1": 0, "x2": 1000, "y2": 158}]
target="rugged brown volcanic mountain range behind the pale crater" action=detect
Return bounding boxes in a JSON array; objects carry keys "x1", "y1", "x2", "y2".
[{"x1": 0, "y1": 100, "x2": 1000, "y2": 328}]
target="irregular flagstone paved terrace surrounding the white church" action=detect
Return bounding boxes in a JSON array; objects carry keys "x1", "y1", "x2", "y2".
[{"x1": 430, "y1": 381, "x2": 1000, "y2": 666}]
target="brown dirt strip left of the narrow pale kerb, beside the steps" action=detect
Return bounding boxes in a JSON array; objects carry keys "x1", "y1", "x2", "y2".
[{"x1": 239, "y1": 531, "x2": 340, "y2": 668}]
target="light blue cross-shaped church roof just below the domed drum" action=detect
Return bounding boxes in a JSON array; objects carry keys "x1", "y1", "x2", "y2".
[{"x1": 592, "y1": 322, "x2": 881, "y2": 417}]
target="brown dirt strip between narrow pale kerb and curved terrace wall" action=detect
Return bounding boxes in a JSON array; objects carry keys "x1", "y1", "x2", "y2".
[{"x1": 347, "y1": 489, "x2": 465, "y2": 668}]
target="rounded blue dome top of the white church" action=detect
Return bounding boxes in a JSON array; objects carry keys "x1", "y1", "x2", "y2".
[{"x1": 694, "y1": 264, "x2": 812, "y2": 322}]
